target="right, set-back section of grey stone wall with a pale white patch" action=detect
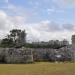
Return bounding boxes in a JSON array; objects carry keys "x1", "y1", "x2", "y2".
[{"x1": 33, "y1": 47, "x2": 74, "y2": 61}]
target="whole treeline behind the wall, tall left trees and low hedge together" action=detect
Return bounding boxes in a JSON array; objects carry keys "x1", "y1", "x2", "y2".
[{"x1": 0, "y1": 29, "x2": 69, "y2": 49}]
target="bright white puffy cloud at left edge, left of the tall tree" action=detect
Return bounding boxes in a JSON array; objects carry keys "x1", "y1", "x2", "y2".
[{"x1": 0, "y1": 10, "x2": 13, "y2": 38}]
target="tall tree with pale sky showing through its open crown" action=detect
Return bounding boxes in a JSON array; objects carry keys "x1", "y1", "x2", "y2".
[{"x1": 10, "y1": 29, "x2": 26, "y2": 46}]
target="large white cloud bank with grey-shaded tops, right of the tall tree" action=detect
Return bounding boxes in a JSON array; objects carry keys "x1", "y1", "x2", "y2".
[{"x1": 26, "y1": 21, "x2": 75, "y2": 42}]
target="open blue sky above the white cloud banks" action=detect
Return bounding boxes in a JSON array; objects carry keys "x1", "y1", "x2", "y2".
[{"x1": 0, "y1": 0, "x2": 75, "y2": 23}]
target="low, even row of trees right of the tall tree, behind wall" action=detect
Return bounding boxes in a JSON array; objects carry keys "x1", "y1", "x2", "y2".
[{"x1": 25, "y1": 40, "x2": 69, "y2": 49}]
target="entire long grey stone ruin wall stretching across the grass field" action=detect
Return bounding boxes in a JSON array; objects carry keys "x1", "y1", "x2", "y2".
[{"x1": 0, "y1": 45, "x2": 75, "y2": 63}]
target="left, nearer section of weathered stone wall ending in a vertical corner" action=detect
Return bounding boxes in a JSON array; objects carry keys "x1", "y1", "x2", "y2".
[{"x1": 0, "y1": 48, "x2": 33, "y2": 63}]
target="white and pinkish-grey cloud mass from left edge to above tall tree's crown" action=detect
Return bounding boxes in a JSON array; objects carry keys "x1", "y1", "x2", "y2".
[{"x1": 0, "y1": 10, "x2": 24, "y2": 37}]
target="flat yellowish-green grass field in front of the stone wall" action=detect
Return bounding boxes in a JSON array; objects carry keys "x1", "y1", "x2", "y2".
[{"x1": 0, "y1": 62, "x2": 75, "y2": 75}]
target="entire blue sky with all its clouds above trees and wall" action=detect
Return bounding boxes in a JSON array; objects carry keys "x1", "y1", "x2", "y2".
[{"x1": 0, "y1": 0, "x2": 75, "y2": 42}]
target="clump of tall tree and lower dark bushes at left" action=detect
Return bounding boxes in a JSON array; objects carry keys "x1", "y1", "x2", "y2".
[{"x1": 1, "y1": 29, "x2": 26, "y2": 47}]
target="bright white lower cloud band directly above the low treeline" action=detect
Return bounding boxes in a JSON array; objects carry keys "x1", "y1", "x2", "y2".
[{"x1": 26, "y1": 24, "x2": 74, "y2": 42}]
